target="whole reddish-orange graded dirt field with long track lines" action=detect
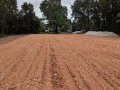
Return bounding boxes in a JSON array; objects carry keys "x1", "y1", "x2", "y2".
[{"x1": 0, "y1": 34, "x2": 120, "y2": 90}]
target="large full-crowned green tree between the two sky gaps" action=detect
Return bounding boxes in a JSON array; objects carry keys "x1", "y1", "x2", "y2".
[{"x1": 40, "y1": 0, "x2": 69, "y2": 33}]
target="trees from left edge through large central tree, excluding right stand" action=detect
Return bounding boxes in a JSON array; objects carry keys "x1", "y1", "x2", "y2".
[{"x1": 0, "y1": 0, "x2": 71, "y2": 36}]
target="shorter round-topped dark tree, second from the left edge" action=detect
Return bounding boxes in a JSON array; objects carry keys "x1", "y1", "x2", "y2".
[{"x1": 18, "y1": 2, "x2": 40, "y2": 33}]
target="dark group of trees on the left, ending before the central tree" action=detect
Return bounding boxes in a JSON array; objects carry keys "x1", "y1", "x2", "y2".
[{"x1": 0, "y1": 0, "x2": 45, "y2": 36}]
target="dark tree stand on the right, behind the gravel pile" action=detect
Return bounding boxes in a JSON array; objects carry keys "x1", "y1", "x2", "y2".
[{"x1": 71, "y1": 0, "x2": 120, "y2": 34}]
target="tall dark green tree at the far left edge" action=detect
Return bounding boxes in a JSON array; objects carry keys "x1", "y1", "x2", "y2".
[{"x1": 0, "y1": 0, "x2": 17, "y2": 36}]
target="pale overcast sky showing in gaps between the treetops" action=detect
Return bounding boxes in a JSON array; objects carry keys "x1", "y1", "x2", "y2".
[{"x1": 17, "y1": 0, "x2": 75, "y2": 18}]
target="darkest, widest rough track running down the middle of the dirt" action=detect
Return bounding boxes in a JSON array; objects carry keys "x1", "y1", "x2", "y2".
[{"x1": 49, "y1": 38, "x2": 65, "y2": 90}]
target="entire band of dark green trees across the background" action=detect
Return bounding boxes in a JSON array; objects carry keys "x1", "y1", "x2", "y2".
[{"x1": 0, "y1": 0, "x2": 120, "y2": 36}]
